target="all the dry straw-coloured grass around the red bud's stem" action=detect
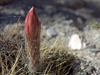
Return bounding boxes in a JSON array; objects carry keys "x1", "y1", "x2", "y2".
[{"x1": 0, "y1": 22, "x2": 75, "y2": 75}]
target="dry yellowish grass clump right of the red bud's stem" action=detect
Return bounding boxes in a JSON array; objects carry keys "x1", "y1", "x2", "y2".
[{"x1": 41, "y1": 38, "x2": 75, "y2": 75}]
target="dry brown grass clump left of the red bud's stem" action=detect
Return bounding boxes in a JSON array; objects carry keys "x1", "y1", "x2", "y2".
[{"x1": 0, "y1": 24, "x2": 25, "y2": 75}]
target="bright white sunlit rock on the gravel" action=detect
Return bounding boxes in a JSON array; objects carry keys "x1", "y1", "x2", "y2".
[{"x1": 68, "y1": 34, "x2": 86, "y2": 50}]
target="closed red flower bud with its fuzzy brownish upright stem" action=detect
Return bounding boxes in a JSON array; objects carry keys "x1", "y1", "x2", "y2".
[{"x1": 24, "y1": 6, "x2": 41, "y2": 73}]
